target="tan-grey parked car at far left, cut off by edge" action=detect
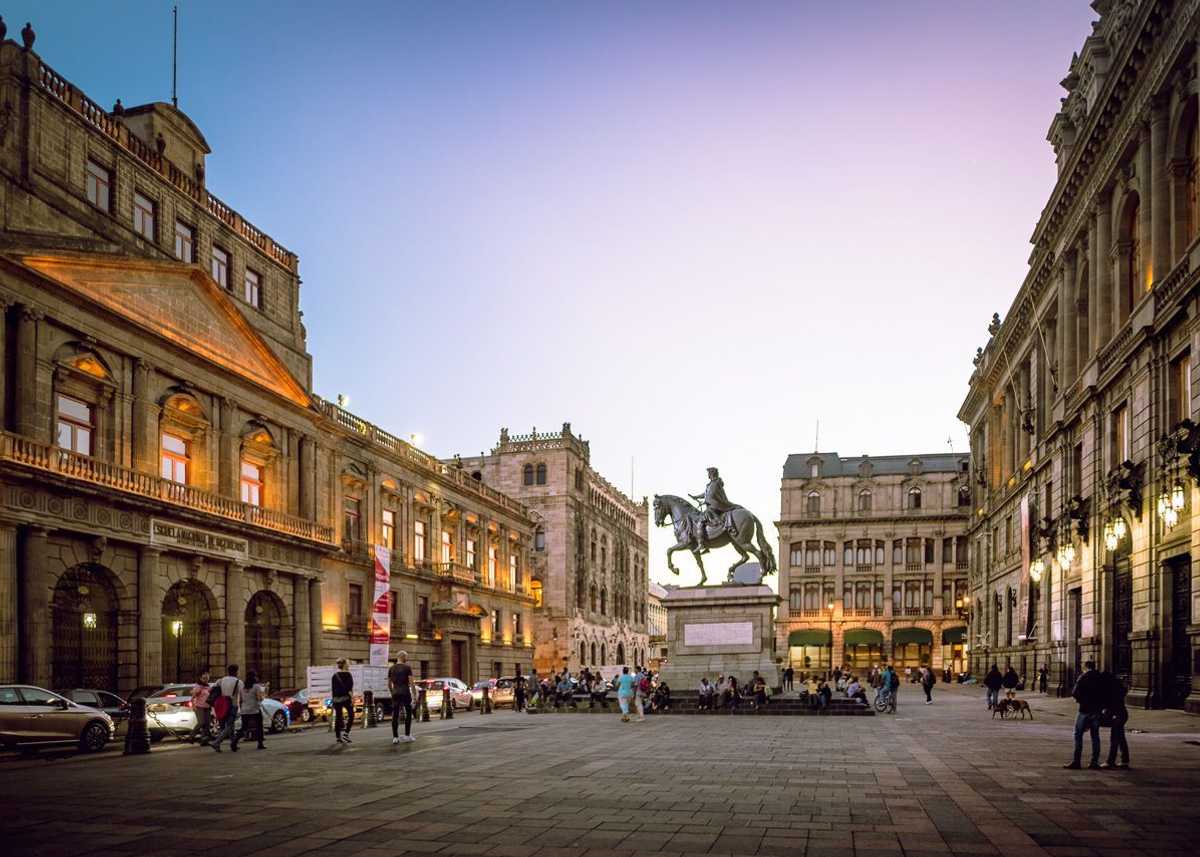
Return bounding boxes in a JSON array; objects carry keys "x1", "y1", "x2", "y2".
[{"x1": 0, "y1": 684, "x2": 113, "y2": 753}]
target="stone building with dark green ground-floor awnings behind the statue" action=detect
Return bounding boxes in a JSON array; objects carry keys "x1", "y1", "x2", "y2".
[{"x1": 775, "y1": 453, "x2": 970, "y2": 671}]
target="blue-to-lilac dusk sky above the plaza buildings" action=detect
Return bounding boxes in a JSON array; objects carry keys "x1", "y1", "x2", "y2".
[{"x1": 18, "y1": 0, "x2": 1094, "y2": 585}]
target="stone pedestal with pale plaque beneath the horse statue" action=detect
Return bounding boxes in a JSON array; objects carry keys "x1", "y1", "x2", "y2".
[{"x1": 660, "y1": 586, "x2": 782, "y2": 691}]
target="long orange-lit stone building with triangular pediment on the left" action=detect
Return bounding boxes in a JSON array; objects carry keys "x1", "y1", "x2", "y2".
[{"x1": 0, "y1": 31, "x2": 533, "y2": 693}]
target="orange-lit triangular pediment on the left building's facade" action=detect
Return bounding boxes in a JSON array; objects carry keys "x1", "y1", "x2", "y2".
[{"x1": 13, "y1": 254, "x2": 311, "y2": 407}]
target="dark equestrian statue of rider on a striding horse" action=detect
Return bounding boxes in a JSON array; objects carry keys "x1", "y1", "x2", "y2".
[{"x1": 654, "y1": 467, "x2": 776, "y2": 586}]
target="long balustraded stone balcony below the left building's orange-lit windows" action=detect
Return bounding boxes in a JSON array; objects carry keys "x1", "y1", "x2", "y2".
[{"x1": 0, "y1": 432, "x2": 335, "y2": 545}]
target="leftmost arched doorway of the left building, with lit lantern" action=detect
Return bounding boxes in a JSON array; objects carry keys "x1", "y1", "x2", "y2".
[{"x1": 50, "y1": 563, "x2": 118, "y2": 693}]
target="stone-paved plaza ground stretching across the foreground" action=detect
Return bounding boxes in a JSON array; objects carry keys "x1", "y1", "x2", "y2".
[{"x1": 0, "y1": 685, "x2": 1200, "y2": 857}]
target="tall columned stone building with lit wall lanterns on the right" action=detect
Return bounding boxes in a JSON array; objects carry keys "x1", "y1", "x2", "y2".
[{"x1": 959, "y1": 0, "x2": 1200, "y2": 711}]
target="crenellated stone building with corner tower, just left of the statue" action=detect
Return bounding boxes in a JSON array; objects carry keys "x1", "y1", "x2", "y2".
[{"x1": 460, "y1": 422, "x2": 649, "y2": 672}]
